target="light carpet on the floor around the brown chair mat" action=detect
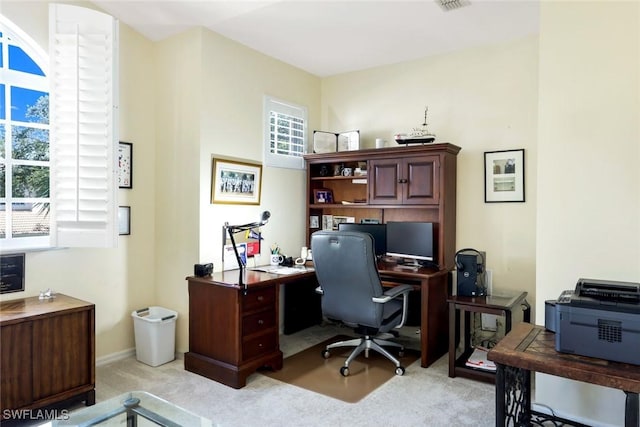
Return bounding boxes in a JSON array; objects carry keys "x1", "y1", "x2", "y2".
[{"x1": 90, "y1": 325, "x2": 495, "y2": 427}]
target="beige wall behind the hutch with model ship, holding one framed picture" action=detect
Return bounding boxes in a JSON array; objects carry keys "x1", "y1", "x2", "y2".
[{"x1": 322, "y1": 36, "x2": 538, "y2": 312}]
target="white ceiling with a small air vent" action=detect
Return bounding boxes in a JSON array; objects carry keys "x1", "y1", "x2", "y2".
[{"x1": 92, "y1": 0, "x2": 540, "y2": 77}]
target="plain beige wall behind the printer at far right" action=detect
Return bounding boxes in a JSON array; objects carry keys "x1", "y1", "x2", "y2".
[{"x1": 535, "y1": 2, "x2": 640, "y2": 425}]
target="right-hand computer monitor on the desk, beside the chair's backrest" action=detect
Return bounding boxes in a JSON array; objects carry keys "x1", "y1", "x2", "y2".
[{"x1": 386, "y1": 221, "x2": 436, "y2": 266}]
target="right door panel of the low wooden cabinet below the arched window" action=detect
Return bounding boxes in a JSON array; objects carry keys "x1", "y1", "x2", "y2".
[{"x1": 33, "y1": 310, "x2": 93, "y2": 400}]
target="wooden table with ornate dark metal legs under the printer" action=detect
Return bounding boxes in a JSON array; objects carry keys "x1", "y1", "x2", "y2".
[{"x1": 487, "y1": 323, "x2": 640, "y2": 426}]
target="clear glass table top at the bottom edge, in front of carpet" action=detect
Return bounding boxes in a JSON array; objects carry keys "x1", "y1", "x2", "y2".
[{"x1": 50, "y1": 391, "x2": 213, "y2": 427}]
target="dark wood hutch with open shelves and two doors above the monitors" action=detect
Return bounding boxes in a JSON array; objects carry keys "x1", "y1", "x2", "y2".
[{"x1": 305, "y1": 143, "x2": 460, "y2": 270}]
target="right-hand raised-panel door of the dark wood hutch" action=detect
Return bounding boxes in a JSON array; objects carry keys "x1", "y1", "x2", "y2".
[{"x1": 403, "y1": 156, "x2": 440, "y2": 205}]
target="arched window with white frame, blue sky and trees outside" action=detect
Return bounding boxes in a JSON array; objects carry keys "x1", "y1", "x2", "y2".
[{"x1": 0, "y1": 16, "x2": 50, "y2": 249}]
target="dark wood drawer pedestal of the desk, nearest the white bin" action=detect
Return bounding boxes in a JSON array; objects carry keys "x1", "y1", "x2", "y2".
[{"x1": 184, "y1": 270, "x2": 296, "y2": 388}]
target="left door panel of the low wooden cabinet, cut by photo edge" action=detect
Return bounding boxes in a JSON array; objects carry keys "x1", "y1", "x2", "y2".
[{"x1": 0, "y1": 322, "x2": 33, "y2": 412}]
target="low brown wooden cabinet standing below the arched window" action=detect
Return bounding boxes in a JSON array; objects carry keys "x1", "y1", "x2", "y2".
[{"x1": 0, "y1": 294, "x2": 95, "y2": 416}]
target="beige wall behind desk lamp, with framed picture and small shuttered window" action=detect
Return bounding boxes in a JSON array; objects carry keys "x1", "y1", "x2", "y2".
[{"x1": 155, "y1": 29, "x2": 320, "y2": 352}]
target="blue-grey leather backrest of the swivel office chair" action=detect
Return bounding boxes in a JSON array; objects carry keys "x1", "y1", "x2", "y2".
[{"x1": 311, "y1": 231, "x2": 384, "y2": 328}]
